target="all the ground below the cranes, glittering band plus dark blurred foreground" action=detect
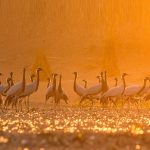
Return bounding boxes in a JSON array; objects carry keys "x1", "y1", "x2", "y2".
[{"x1": 0, "y1": 107, "x2": 150, "y2": 150}]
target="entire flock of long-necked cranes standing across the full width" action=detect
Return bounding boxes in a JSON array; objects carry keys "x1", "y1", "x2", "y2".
[{"x1": 0, "y1": 68, "x2": 150, "y2": 111}]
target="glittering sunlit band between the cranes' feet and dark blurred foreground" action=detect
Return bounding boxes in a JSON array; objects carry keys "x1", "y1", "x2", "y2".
[{"x1": 0, "y1": 108, "x2": 150, "y2": 135}]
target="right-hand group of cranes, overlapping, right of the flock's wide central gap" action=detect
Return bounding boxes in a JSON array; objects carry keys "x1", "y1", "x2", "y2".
[{"x1": 74, "y1": 71, "x2": 150, "y2": 106}]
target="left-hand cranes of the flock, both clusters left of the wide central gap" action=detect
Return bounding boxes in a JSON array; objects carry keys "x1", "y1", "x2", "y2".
[{"x1": 0, "y1": 68, "x2": 68, "y2": 111}]
